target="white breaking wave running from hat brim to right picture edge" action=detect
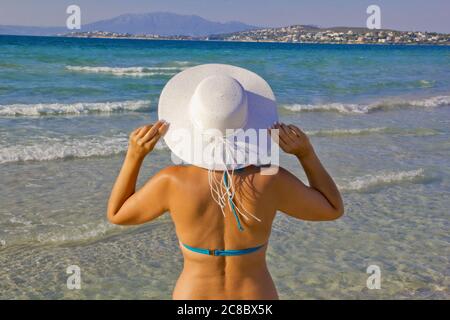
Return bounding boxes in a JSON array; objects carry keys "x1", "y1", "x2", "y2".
[{"x1": 281, "y1": 96, "x2": 450, "y2": 114}]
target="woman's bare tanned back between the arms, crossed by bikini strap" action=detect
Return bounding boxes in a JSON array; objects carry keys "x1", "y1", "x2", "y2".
[{"x1": 165, "y1": 166, "x2": 278, "y2": 299}]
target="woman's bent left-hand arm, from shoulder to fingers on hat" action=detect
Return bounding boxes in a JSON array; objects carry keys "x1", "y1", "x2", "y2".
[{"x1": 107, "y1": 121, "x2": 168, "y2": 224}]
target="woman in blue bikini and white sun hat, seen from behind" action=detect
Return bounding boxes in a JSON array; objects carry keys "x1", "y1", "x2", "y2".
[{"x1": 107, "y1": 65, "x2": 344, "y2": 299}]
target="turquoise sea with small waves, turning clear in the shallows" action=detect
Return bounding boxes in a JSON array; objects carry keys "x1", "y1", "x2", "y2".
[{"x1": 0, "y1": 36, "x2": 450, "y2": 299}]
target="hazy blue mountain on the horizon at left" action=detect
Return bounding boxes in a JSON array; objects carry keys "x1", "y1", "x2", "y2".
[{"x1": 0, "y1": 12, "x2": 257, "y2": 36}]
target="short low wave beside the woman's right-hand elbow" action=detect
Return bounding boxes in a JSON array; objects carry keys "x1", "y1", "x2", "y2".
[{"x1": 339, "y1": 168, "x2": 426, "y2": 191}]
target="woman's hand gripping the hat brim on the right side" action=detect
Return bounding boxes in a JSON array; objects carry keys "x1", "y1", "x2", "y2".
[{"x1": 270, "y1": 122, "x2": 314, "y2": 158}]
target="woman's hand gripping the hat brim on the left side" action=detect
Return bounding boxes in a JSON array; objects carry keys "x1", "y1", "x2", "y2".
[{"x1": 128, "y1": 120, "x2": 169, "y2": 160}]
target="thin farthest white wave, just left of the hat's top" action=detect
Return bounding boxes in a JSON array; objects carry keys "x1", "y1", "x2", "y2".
[{"x1": 66, "y1": 66, "x2": 185, "y2": 77}]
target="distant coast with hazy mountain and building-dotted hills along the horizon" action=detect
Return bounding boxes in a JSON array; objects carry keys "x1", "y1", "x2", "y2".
[{"x1": 0, "y1": 12, "x2": 450, "y2": 45}]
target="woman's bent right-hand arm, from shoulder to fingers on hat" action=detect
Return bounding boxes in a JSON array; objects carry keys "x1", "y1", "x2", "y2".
[{"x1": 273, "y1": 124, "x2": 344, "y2": 220}]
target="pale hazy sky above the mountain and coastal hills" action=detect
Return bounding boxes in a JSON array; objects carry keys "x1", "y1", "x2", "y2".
[{"x1": 0, "y1": 0, "x2": 450, "y2": 33}]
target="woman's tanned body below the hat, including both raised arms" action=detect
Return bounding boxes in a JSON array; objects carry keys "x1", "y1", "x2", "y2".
[{"x1": 107, "y1": 122, "x2": 343, "y2": 299}]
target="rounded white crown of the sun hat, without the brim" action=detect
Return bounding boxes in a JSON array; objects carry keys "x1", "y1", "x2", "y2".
[{"x1": 190, "y1": 75, "x2": 248, "y2": 134}]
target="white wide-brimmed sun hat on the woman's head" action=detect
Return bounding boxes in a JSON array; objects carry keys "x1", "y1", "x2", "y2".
[{"x1": 158, "y1": 64, "x2": 278, "y2": 171}]
